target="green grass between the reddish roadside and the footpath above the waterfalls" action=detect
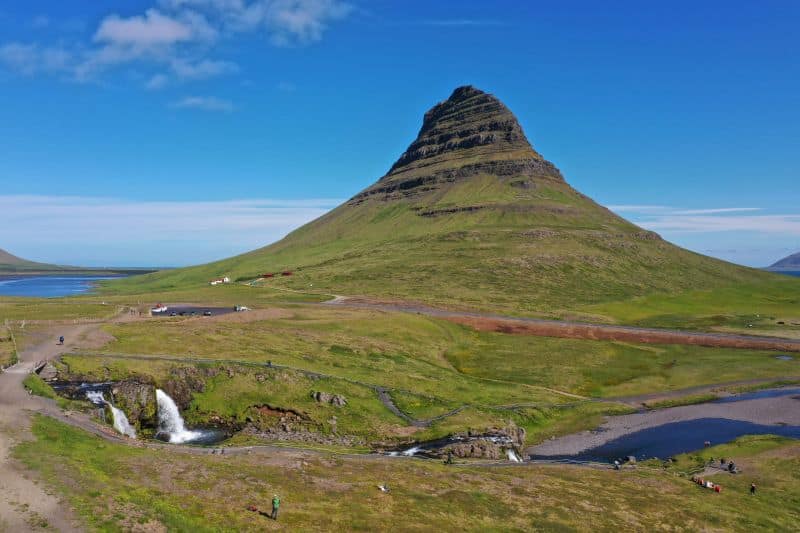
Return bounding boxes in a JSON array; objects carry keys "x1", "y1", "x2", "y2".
[{"x1": 94, "y1": 306, "x2": 800, "y2": 400}]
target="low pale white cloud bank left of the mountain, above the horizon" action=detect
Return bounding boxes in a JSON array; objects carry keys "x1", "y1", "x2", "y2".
[{"x1": 0, "y1": 195, "x2": 340, "y2": 265}]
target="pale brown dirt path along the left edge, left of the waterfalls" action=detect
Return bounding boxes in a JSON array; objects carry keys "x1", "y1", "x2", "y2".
[{"x1": 0, "y1": 324, "x2": 99, "y2": 532}]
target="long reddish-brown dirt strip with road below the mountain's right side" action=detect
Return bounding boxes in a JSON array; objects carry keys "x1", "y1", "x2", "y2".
[{"x1": 324, "y1": 296, "x2": 800, "y2": 352}]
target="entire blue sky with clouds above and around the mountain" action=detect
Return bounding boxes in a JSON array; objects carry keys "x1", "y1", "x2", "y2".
[{"x1": 0, "y1": 0, "x2": 800, "y2": 266}]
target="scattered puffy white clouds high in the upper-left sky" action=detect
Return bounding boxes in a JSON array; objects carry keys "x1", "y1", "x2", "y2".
[{"x1": 0, "y1": 0, "x2": 352, "y2": 85}]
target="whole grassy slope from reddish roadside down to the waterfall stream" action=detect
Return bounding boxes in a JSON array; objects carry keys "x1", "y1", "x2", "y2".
[{"x1": 45, "y1": 305, "x2": 800, "y2": 444}]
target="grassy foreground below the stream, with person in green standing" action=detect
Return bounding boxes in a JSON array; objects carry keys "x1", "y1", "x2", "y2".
[{"x1": 14, "y1": 417, "x2": 800, "y2": 532}]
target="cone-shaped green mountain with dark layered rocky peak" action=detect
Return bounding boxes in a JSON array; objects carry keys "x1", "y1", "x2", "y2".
[{"x1": 116, "y1": 86, "x2": 771, "y2": 313}]
